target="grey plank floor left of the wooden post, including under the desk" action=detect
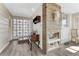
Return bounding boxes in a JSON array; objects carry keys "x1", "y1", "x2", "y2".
[{"x1": 0, "y1": 40, "x2": 42, "y2": 56}]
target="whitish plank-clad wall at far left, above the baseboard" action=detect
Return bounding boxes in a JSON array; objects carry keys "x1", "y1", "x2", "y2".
[{"x1": 0, "y1": 4, "x2": 11, "y2": 52}]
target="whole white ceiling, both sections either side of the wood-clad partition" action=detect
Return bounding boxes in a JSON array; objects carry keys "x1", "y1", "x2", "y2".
[{"x1": 4, "y1": 3, "x2": 79, "y2": 17}]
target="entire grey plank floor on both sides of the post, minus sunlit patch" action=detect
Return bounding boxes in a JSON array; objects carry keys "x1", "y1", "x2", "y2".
[{"x1": 0, "y1": 41, "x2": 79, "y2": 56}]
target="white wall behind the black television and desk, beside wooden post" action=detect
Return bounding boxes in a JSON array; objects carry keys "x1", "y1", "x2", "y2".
[{"x1": 33, "y1": 4, "x2": 42, "y2": 49}]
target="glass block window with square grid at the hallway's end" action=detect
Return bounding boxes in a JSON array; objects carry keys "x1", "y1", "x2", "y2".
[{"x1": 13, "y1": 19, "x2": 32, "y2": 38}]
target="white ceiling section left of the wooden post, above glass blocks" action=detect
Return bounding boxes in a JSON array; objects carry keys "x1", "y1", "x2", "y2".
[{"x1": 4, "y1": 3, "x2": 40, "y2": 17}]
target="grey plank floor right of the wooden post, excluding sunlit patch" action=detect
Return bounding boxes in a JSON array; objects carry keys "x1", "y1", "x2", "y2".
[{"x1": 47, "y1": 42, "x2": 79, "y2": 56}]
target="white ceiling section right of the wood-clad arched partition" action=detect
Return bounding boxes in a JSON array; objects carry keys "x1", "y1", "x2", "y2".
[{"x1": 59, "y1": 3, "x2": 79, "y2": 13}]
